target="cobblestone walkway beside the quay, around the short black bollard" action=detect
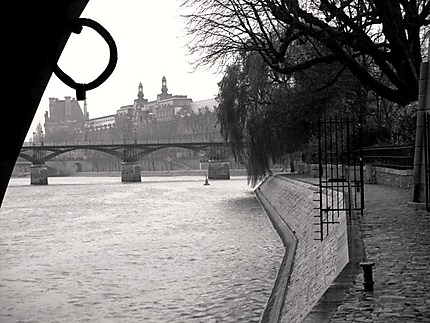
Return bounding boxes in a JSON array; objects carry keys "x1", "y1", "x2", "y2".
[{"x1": 330, "y1": 185, "x2": 430, "y2": 322}]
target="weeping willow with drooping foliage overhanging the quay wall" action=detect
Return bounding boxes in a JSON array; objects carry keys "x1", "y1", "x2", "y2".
[{"x1": 217, "y1": 53, "x2": 356, "y2": 185}]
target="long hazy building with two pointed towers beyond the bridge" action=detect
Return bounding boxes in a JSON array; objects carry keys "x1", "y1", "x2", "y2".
[{"x1": 45, "y1": 76, "x2": 220, "y2": 142}]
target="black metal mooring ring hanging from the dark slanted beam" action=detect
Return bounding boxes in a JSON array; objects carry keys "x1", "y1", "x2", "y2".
[{"x1": 52, "y1": 18, "x2": 118, "y2": 100}]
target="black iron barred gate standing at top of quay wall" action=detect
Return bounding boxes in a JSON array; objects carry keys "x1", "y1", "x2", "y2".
[{"x1": 315, "y1": 117, "x2": 364, "y2": 241}]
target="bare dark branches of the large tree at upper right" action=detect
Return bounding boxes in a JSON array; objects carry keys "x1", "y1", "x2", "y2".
[{"x1": 183, "y1": 0, "x2": 430, "y2": 105}]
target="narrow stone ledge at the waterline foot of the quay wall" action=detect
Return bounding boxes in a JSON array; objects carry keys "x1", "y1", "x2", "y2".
[{"x1": 254, "y1": 177, "x2": 297, "y2": 323}]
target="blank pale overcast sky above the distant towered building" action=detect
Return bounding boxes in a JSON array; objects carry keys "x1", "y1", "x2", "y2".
[{"x1": 29, "y1": 0, "x2": 222, "y2": 139}]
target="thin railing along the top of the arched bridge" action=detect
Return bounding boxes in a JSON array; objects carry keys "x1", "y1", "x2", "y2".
[{"x1": 22, "y1": 137, "x2": 225, "y2": 147}]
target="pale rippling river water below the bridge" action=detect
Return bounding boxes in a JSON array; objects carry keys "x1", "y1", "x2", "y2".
[{"x1": 0, "y1": 177, "x2": 284, "y2": 322}]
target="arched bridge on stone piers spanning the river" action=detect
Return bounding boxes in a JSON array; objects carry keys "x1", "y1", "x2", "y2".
[{"x1": 19, "y1": 140, "x2": 232, "y2": 185}]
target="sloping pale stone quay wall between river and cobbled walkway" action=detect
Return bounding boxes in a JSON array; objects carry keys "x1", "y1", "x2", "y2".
[{"x1": 255, "y1": 176, "x2": 349, "y2": 323}]
